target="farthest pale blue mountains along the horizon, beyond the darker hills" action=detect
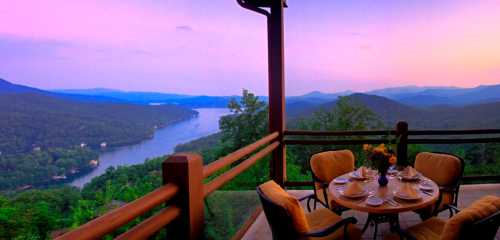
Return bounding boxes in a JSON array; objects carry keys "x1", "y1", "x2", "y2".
[{"x1": 53, "y1": 80, "x2": 500, "y2": 108}]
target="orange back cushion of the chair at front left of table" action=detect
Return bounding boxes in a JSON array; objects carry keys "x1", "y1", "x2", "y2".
[{"x1": 259, "y1": 180, "x2": 310, "y2": 233}]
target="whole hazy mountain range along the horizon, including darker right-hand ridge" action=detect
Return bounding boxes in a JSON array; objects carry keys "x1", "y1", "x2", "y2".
[{"x1": 0, "y1": 80, "x2": 500, "y2": 129}]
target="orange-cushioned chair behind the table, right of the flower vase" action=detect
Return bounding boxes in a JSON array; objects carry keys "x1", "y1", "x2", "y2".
[{"x1": 415, "y1": 152, "x2": 465, "y2": 220}]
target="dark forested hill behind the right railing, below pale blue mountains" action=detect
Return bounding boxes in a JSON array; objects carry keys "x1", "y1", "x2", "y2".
[{"x1": 287, "y1": 93, "x2": 500, "y2": 129}]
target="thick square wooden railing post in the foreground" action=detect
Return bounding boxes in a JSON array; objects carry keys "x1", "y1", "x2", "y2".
[{"x1": 163, "y1": 153, "x2": 205, "y2": 240}]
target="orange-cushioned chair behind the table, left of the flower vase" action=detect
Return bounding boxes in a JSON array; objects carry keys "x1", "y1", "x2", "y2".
[{"x1": 307, "y1": 150, "x2": 355, "y2": 214}]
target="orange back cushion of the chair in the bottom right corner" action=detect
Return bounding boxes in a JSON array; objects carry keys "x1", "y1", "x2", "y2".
[{"x1": 441, "y1": 196, "x2": 500, "y2": 240}]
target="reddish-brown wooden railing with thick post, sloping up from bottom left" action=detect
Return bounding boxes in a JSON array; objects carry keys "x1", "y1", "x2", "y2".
[{"x1": 56, "y1": 132, "x2": 280, "y2": 240}]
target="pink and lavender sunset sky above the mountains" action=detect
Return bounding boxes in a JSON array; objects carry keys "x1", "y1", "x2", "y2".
[{"x1": 0, "y1": 0, "x2": 500, "y2": 95}]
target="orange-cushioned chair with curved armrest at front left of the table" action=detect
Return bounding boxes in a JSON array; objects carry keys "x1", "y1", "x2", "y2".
[{"x1": 257, "y1": 181, "x2": 361, "y2": 240}]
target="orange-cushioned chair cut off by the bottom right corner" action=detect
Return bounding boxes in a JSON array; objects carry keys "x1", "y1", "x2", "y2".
[{"x1": 384, "y1": 196, "x2": 500, "y2": 240}]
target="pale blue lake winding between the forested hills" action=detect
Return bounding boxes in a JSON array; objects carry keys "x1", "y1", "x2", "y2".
[{"x1": 70, "y1": 108, "x2": 230, "y2": 187}]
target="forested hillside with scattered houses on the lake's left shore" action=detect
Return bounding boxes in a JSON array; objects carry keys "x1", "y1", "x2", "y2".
[{"x1": 0, "y1": 93, "x2": 197, "y2": 190}]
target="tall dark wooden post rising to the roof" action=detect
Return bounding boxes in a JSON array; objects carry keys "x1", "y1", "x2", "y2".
[{"x1": 267, "y1": 0, "x2": 286, "y2": 186}]
